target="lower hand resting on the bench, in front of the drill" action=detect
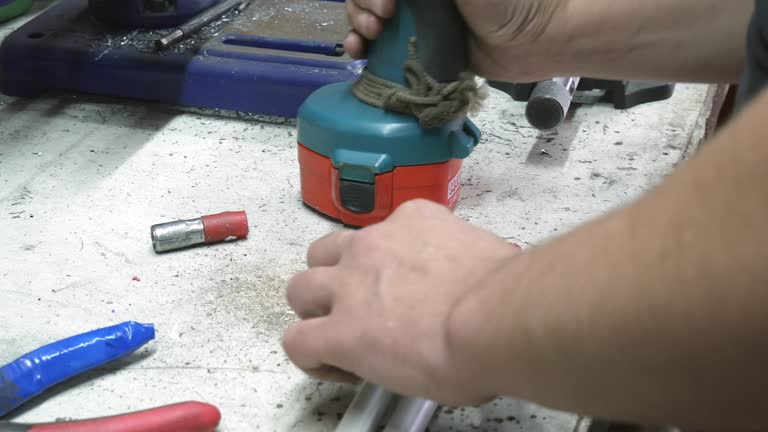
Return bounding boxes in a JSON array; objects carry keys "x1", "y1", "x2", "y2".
[{"x1": 283, "y1": 201, "x2": 519, "y2": 405}]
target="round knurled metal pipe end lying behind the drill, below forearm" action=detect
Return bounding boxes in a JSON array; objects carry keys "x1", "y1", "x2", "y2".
[{"x1": 525, "y1": 77, "x2": 580, "y2": 131}]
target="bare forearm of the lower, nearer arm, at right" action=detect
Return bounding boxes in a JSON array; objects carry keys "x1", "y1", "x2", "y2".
[{"x1": 448, "y1": 88, "x2": 768, "y2": 430}]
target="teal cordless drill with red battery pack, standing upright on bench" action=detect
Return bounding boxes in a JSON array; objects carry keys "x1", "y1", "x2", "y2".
[{"x1": 297, "y1": 0, "x2": 480, "y2": 226}]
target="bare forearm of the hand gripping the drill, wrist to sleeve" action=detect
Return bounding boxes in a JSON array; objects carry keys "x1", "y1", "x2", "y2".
[{"x1": 555, "y1": 0, "x2": 754, "y2": 82}]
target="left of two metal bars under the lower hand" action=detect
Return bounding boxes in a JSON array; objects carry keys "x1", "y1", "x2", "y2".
[{"x1": 336, "y1": 382, "x2": 395, "y2": 432}]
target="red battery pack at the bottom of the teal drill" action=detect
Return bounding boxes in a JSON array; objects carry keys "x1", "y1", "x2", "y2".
[{"x1": 298, "y1": 143, "x2": 463, "y2": 227}]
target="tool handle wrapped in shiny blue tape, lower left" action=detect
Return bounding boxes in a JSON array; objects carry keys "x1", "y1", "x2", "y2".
[{"x1": 0, "y1": 321, "x2": 155, "y2": 417}]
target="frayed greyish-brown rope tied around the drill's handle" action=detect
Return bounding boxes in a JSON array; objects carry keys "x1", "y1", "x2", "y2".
[{"x1": 352, "y1": 38, "x2": 488, "y2": 129}]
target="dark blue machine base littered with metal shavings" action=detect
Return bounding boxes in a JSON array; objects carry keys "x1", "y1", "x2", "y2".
[{"x1": 0, "y1": 0, "x2": 365, "y2": 117}]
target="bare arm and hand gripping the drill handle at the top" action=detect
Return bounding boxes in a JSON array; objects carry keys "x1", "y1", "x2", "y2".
[{"x1": 345, "y1": 0, "x2": 754, "y2": 82}]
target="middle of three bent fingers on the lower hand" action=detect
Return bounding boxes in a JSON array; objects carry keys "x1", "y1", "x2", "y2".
[{"x1": 285, "y1": 267, "x2": 339, "y2": 319}]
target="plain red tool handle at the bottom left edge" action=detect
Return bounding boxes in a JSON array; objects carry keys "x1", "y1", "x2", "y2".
[{"x1": 13, "y1": 402, "x2": 221, "y2": 432}]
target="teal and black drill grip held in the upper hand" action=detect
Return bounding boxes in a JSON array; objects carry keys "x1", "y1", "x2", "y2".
[{"x1": 368, "y1": 0, "x2": 469, "y2": 85}]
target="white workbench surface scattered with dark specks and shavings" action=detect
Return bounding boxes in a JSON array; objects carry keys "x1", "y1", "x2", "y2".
[{"x1": 0, "y1": 4, "x2": 711, "y2": 432}]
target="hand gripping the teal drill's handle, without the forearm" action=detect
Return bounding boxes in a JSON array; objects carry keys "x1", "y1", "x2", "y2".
[{"x1": 344, "y1": 0, "x2": 572, "y2": 82}]
